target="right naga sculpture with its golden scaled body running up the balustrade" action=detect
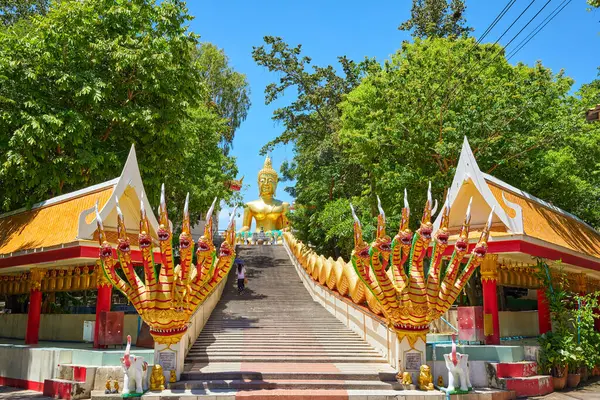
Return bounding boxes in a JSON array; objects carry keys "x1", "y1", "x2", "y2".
[{"x1": 284, "y1": 184, "x2": 494, "y2": 346}]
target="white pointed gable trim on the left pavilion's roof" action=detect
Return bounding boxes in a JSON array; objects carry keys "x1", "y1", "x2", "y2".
[{"x1": 77, "y1": 145, "x2": 158, "y2": 240}]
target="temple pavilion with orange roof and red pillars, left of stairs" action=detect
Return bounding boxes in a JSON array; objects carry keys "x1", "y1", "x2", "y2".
[{"x1": 0, "y1": 146, "x2": 159, "y2": 345}]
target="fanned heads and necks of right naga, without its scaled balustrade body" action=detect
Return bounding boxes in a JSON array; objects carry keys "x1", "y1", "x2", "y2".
[{"x1": 352, "y1": 185, "x2": 494, "y2": 344}]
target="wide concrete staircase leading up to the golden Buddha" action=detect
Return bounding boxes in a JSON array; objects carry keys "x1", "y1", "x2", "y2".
[{"x1": 178, "y1": 246, "x2": 399, "y2": 398}]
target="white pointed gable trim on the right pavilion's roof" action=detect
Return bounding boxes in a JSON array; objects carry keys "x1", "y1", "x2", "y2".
[{"x1": 433, "y1": 136, "x2": 523, "y2": 233}]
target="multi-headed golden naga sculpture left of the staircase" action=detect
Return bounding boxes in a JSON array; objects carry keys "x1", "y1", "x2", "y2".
[{"x1": 96, "y1": 185, "x2": 235, "y2": 344}]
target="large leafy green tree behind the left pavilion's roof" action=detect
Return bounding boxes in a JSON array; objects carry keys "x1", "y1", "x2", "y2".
[{"x1": 0, "y1": 0, "x2": 236, "y2": 221}]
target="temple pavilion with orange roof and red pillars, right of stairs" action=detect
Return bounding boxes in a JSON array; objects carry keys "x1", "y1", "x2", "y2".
[{"x1": 434, "y1": 138, "x2": 600, "y2": 344}]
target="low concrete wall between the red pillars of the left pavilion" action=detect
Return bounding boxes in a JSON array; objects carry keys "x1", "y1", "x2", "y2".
[{"x1": 0, "y1": 314, "x2": 138, "y2": 343}]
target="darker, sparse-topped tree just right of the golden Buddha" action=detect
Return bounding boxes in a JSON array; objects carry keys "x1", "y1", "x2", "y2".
[{"x1": 252, "y1": 36, "x2": 378, "y2": 253}]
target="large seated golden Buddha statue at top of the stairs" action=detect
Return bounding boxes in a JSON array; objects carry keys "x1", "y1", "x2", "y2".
[{"x1": 240, "y1": 156, "x2": 290, "y2": 234}]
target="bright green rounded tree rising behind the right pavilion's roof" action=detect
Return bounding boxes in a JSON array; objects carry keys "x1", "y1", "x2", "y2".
[{"x1": 339, "y1": 38, "x2": 600, "y2": 230}]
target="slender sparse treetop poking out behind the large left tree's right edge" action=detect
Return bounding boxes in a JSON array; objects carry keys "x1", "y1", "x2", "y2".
[{"x1": 197, "y1": 43, "x2": 250, "y2": 154}]
